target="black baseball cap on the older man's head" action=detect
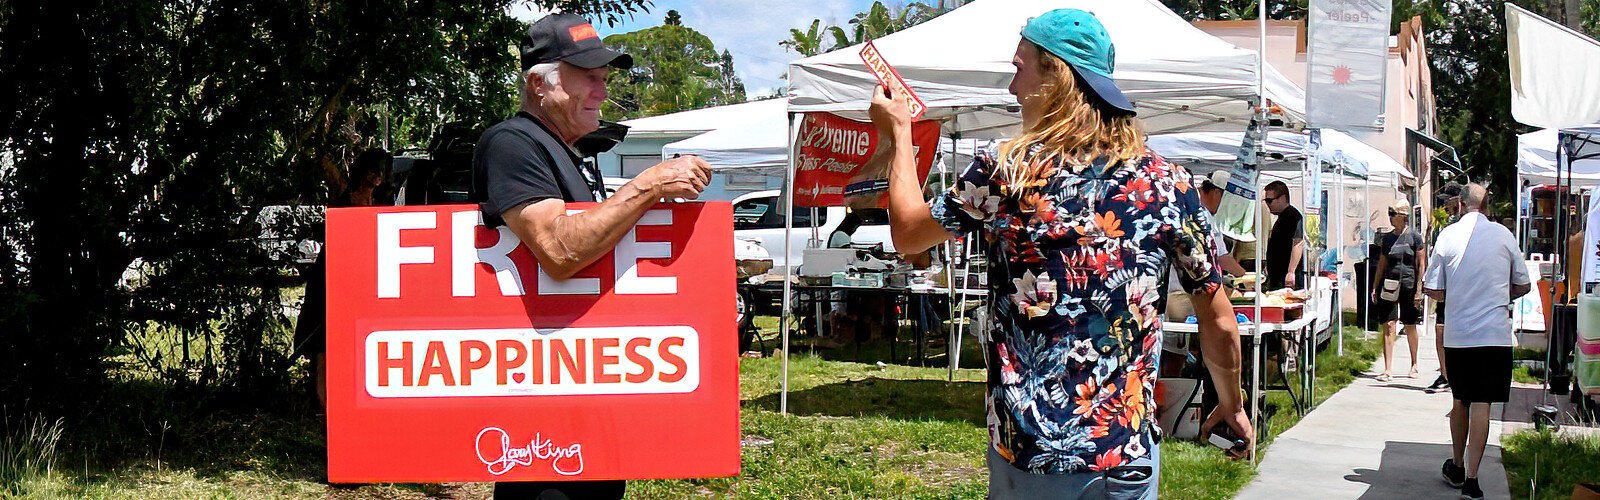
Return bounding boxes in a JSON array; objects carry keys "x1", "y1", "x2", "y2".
[{"x1": 518, "y1": 14, "x2": 634, "y2": 71}]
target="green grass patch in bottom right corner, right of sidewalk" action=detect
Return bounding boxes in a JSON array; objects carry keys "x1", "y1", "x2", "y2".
[{"x1": 1501, "y1": 429, "x2": 1600, "y2": 498}]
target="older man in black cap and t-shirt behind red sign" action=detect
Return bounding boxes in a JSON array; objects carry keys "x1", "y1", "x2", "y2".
[{"x1": 472, "y1": 14, "x2": 710, "y2": 498}]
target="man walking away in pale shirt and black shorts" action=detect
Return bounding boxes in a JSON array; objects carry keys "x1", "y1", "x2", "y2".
[{"x1": 1424, "y1": 184, "x2": 1531, "y2": 498}]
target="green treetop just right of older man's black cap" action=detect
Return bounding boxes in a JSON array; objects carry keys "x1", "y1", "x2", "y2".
[{"x1": 602, "y1": 24, "x2": 744, "y2": 120}]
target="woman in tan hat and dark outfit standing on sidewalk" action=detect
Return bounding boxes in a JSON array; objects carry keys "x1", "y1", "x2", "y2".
[{"x1": 1373, "y1": 199, "x2": 1424, "y2": 381}]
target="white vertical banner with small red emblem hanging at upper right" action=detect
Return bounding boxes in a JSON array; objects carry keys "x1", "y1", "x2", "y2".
[{"x1": 1306, "y1": 0, "x2": 1394, "y2": 130}]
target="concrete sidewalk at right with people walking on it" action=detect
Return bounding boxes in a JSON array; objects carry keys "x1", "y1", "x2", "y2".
[{"x1": 1238, "y1": 329, "x2": 1510, "y2": 500}]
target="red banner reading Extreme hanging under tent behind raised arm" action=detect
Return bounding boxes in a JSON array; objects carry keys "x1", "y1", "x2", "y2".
[{"x1": 794, "y1": 112, "x2": 939, "y2": 208}]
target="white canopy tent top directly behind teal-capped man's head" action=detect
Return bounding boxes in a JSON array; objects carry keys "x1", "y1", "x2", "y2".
[{"x1": 789, "y1": 0, "x2": 1306, "y2": 138}]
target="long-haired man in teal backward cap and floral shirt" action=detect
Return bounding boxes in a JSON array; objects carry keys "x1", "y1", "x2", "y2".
[{"x1": 869, "y1": 8, "x2": 1254, "y2": 500}]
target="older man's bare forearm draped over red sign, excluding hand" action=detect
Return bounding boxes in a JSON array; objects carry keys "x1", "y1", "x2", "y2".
[{"x1": 506, "y1": 183, "x2": 658, "y2": 279}]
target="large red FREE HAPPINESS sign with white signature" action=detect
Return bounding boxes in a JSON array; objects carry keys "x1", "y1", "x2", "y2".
[{"x1": 328, "y1": 204, "x2": 739, "y2": 482}]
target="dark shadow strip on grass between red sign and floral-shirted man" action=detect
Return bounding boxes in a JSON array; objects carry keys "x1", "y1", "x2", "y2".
[{"x1": 747, "y1": 377, "x2": 984, "y2": 428}]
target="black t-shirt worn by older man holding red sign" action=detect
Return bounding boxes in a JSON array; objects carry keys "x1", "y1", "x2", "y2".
[{"x1": 472, "y1": 112, "x2": 603, "y2": 228}]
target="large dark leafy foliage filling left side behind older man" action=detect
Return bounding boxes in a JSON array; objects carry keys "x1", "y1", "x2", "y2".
[{"x1": 0, "y1": 0, "x2": 648, "y2": 405}]
